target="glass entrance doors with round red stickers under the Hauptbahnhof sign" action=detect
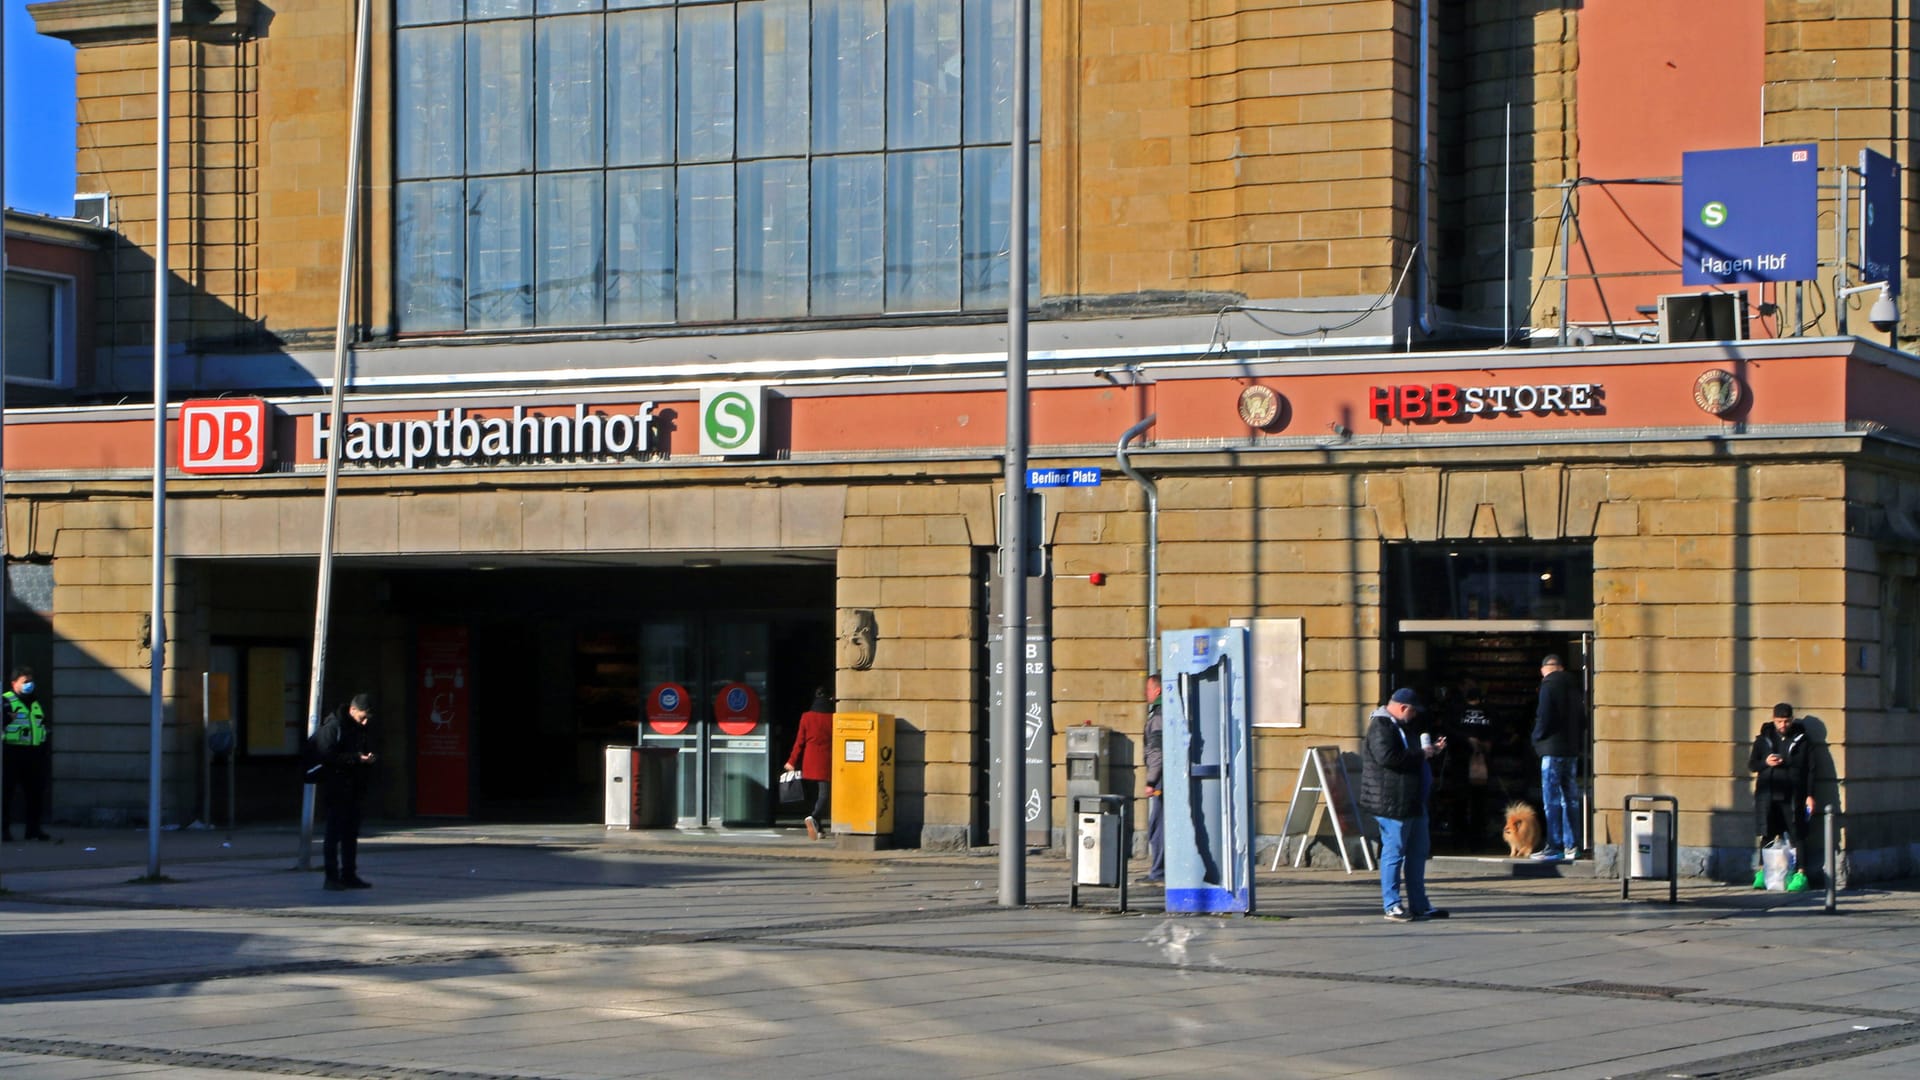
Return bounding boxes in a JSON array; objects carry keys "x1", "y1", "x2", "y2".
[{"x1": 639, "y1": 615, "x2": 774, "y2": 828}]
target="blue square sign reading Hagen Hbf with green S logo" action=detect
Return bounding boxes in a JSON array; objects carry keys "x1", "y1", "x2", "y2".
[{"x1": 1680, "y1": 142, "x2": 1820, "y2": 284}]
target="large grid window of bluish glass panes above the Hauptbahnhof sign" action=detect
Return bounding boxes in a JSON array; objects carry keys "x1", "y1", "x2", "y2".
[{"x1": 394, "y1": 0, "x2": 1039, "y2": 332}]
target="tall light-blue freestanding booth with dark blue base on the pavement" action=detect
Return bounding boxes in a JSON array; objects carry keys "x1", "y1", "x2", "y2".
[{"x1": 1160, "y1": 626, "x2": 1254, "y2": 913}]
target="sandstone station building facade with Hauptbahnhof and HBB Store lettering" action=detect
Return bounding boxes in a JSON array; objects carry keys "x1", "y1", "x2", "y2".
[{"x1": 6, "y1": 0, "x2": 1920, "y2": 876}]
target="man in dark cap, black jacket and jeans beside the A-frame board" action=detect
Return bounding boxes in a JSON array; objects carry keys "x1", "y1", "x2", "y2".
[{"x1": 1359, "y1": 688, "x2": 1448, "y2": 922}]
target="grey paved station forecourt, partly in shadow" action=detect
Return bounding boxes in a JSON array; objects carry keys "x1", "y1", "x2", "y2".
[{"x1": 0, "y1": 824, "x2": 1920, "y2": 1080}]
